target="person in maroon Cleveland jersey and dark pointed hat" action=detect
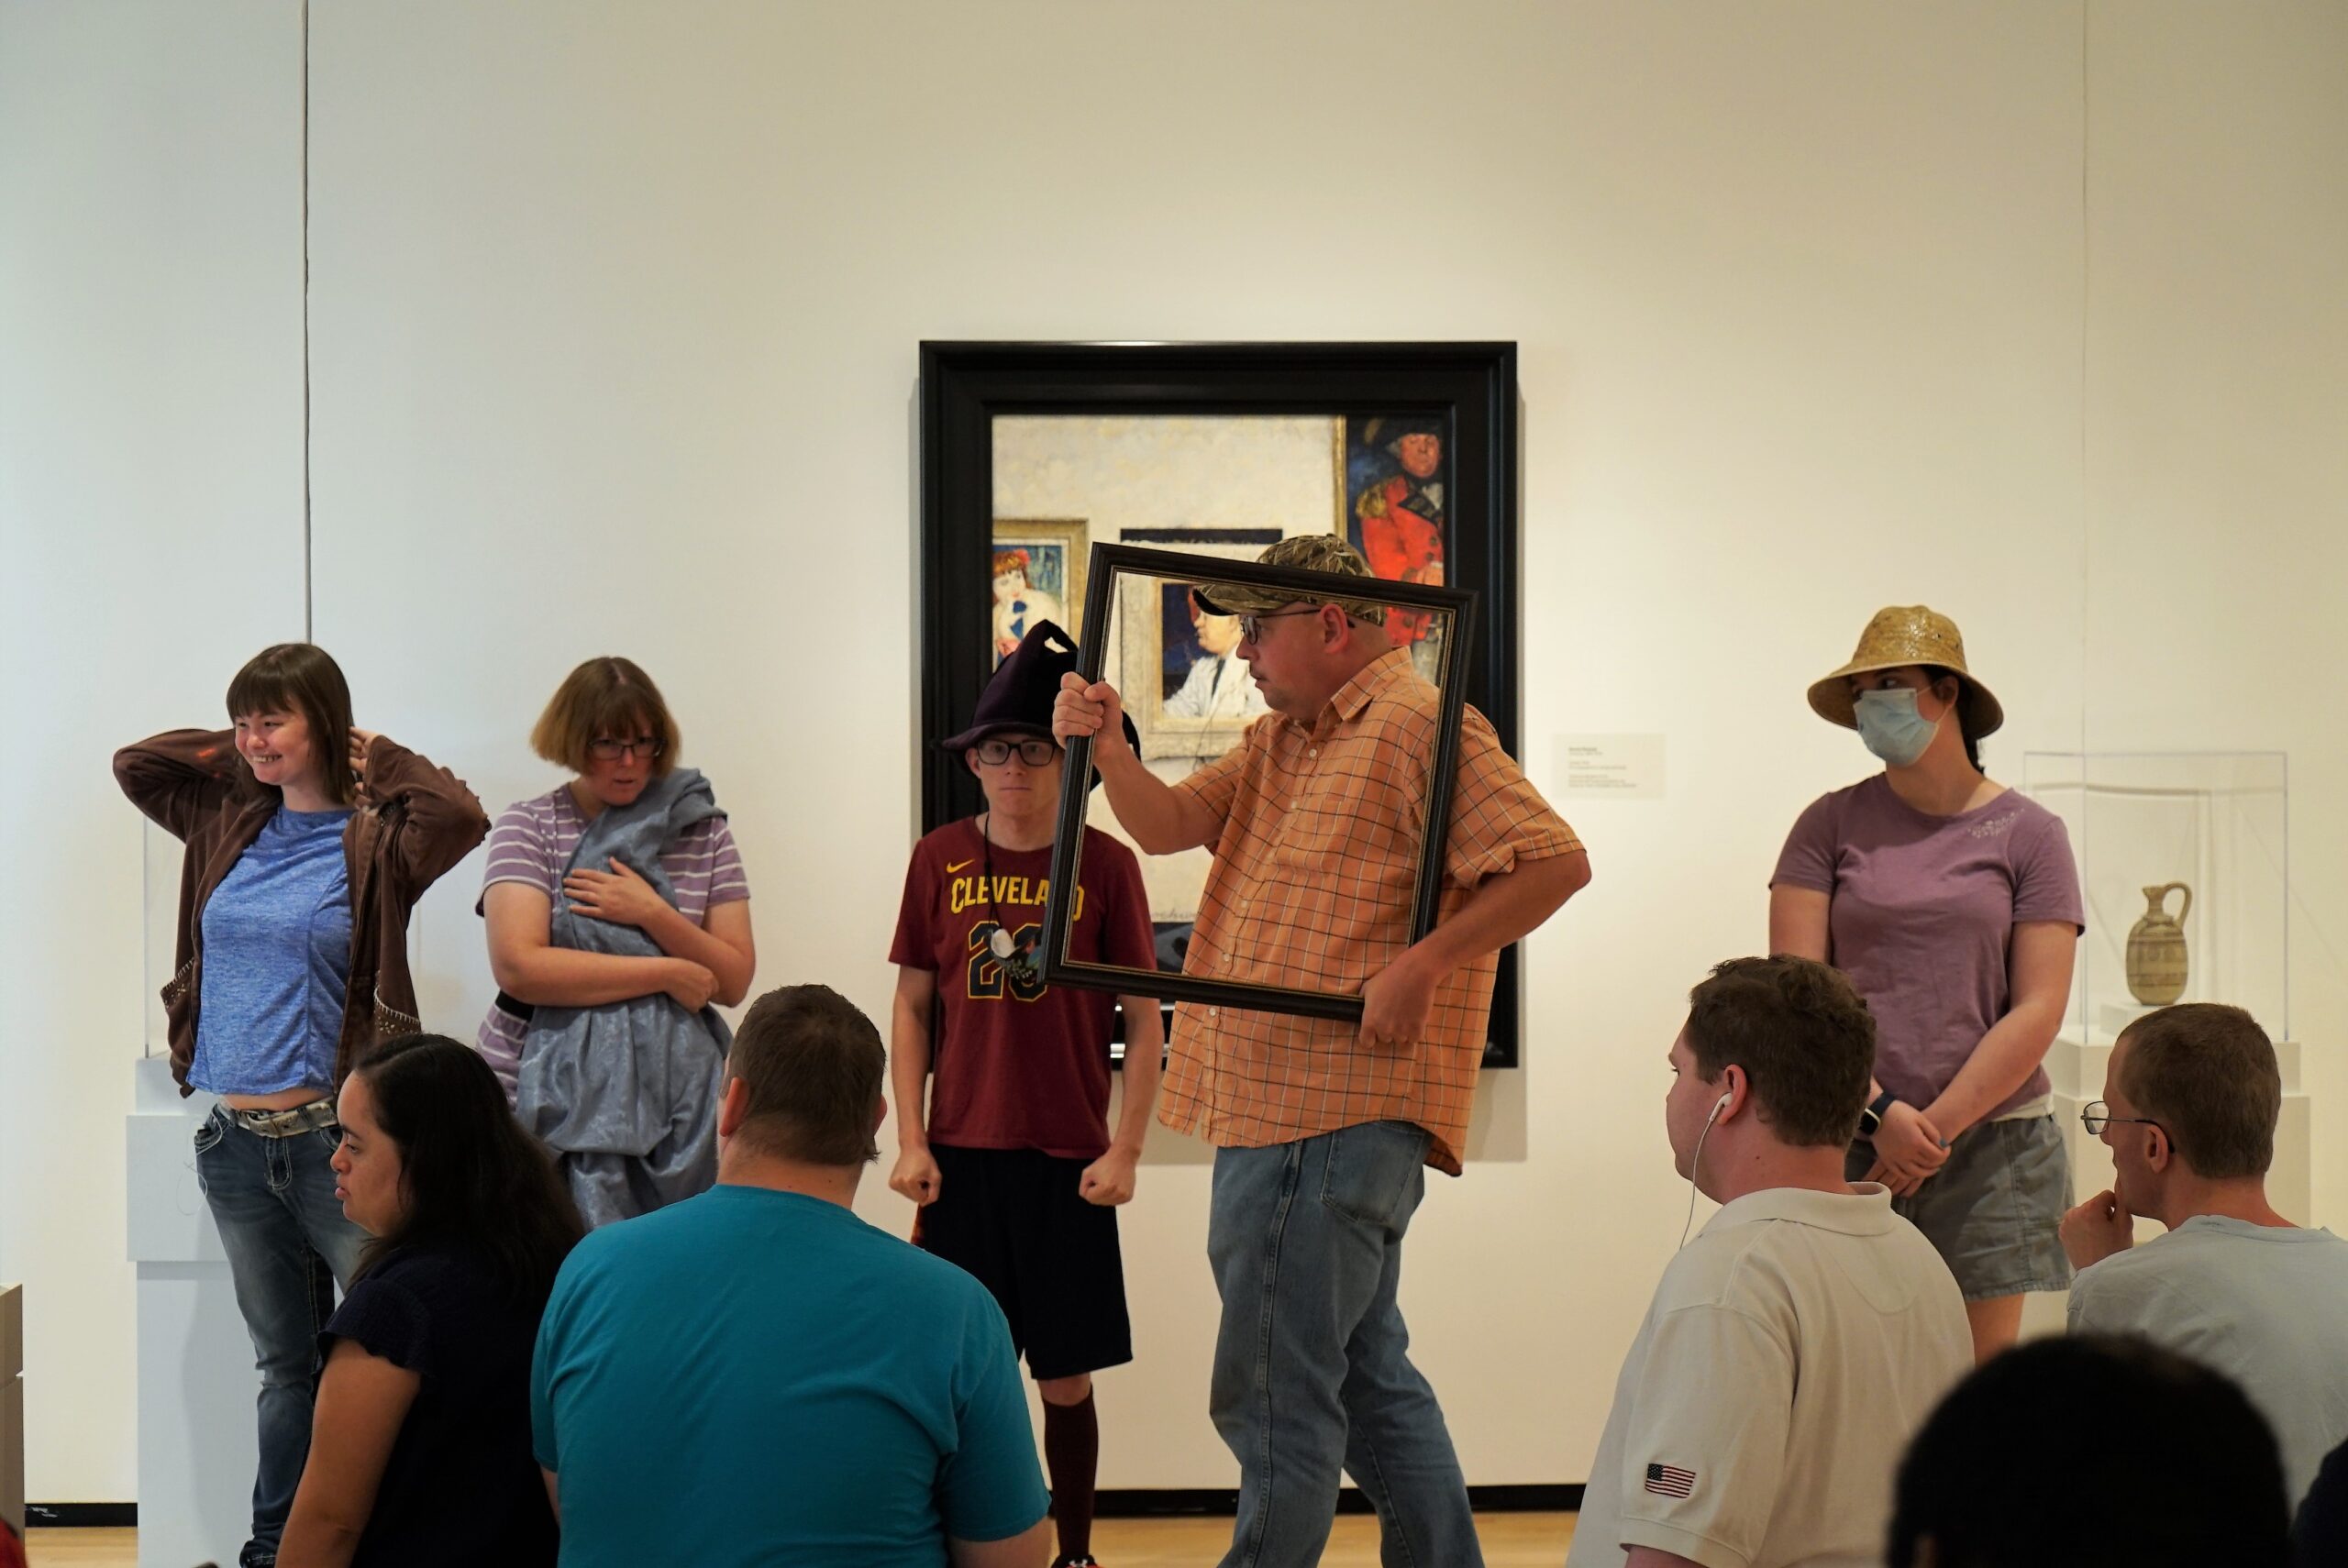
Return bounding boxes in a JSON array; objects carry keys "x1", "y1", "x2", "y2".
[{"x1": 890, "y1": 622, "x2": 1165, "y2": 1568}]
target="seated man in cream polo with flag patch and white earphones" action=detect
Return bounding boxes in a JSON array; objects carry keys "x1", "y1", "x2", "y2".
[{"x1": 1567, "y1": 957, "x2": 1972, "y2": 1568}]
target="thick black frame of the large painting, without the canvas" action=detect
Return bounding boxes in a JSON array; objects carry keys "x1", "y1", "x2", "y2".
[{"x1": 918, "y1": 343, "x2": 1523, "y2": 1068}]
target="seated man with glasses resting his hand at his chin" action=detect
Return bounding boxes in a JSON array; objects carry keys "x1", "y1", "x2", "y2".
[{"x1": 2062, "y1": 1002, "x2": 2348, "y2": 1505}]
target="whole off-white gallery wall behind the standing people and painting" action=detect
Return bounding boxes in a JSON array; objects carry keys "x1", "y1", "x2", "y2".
[{"x1": 0, "y1": 0, "x2": 2348, "y2": 1500}]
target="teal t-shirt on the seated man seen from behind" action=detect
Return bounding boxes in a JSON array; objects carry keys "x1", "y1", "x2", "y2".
[{"x1": 531, "y1": 1186, "x2": 1049, "y2": 1568}]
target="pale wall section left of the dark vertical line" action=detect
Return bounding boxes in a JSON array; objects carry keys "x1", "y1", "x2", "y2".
[{"x1": 0, "y1": 5, "x2": 303, "y2": 1502}]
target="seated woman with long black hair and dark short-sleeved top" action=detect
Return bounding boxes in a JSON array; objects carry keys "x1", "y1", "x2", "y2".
[{"x1": 277, "y1": 1035, "x2": 580, "y2": 1568}]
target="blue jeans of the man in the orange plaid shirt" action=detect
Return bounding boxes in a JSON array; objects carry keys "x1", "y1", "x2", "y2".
[{"x1": 1207, "y1": 1122, "x2": 1484, "y2": 1568}]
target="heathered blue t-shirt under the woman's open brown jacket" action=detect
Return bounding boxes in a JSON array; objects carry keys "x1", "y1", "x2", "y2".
[{"x1": 188, "y1": 805, "x2": 349, "y2": 1094}]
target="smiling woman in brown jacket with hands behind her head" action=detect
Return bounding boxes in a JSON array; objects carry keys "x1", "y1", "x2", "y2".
[{"x1": 115, "y1": 643, "x2": 488, "y2": 1568}]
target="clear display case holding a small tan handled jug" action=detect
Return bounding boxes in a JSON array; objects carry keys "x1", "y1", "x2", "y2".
[{"x1": 2021, "y1": 751, "x2": 2292, "y2": 1047}]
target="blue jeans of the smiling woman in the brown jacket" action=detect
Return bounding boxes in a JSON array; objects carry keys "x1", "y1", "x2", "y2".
[{"x1": 194, "y1": 1106, "x2": 366, "y2": 1561}]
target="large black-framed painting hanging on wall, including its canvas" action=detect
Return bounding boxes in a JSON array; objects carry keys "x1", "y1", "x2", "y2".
[{"x1": 921, "y1": 343, "x2": 1522, "y2": 1066}]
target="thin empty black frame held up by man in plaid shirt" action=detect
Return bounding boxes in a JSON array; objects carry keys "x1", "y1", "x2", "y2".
[{"x1": 1036, "y1": 545, "x2": 1475, "y2": 1023}]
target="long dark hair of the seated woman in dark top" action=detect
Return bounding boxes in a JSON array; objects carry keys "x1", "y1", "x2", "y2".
[{"x1": 352, "y1": 1035, "x2": 582, "y2": 1305}]
